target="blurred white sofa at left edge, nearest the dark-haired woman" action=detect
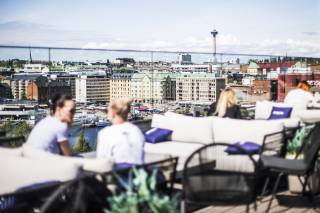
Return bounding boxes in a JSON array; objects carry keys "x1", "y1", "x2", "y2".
[{"x1": 0, "y1": 144, "x2": 113, "y2": 194}]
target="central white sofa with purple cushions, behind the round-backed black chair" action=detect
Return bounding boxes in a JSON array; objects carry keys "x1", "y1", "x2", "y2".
[{"x1": 145, "y1": 113, "x2": 284, "y2": 171}]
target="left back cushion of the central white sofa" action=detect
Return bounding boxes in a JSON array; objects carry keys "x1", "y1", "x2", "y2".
[{"x1": 151, "y1": 113, "x2": 213, "y2": 144}]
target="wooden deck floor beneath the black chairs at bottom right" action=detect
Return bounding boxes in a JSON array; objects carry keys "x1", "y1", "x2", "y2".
[{"x1": 195, "y1": 192, "x2": 320, "y2": 213}]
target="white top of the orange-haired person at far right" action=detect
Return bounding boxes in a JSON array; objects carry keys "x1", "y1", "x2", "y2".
[{"x1": 284, "y1": 88, "x2": 313, "y2": 109}]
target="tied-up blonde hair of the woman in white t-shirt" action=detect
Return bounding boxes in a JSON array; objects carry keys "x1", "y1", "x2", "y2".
[{"x1": 109, "y1": 98, "x2": 132, "y2": 121}]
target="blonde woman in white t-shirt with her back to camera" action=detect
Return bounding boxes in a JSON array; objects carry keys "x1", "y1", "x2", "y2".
[{"x1": 97, "y1": 99, "x2": 144, "y2": 165}]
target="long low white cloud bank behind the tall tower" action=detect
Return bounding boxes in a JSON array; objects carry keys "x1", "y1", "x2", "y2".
[{"x1": 83, "y1": 34, "x2": 320, "y2": 57}]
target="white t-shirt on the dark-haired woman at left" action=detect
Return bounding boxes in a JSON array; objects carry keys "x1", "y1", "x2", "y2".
[{"x1": 27, "y1": 116, "x2": 68, "y2": 154}]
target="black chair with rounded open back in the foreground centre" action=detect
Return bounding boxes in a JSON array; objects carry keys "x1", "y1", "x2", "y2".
[{"x1": 181, "y1": 143, "x2": 258, "y2": 212}]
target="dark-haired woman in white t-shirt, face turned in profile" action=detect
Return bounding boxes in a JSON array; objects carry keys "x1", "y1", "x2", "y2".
[{"x1": 26, "y1": 94, "x2": 75, "y2": 156}]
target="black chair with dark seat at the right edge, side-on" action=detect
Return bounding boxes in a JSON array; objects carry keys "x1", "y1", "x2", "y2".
[{"x1": 261, "y1": 123, "x2": 320, "y2": 212}]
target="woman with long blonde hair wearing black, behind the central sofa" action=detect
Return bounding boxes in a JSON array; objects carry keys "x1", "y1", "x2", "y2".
[{"x1": 208, "y1": 88, "x2": 241, "y2": 119}]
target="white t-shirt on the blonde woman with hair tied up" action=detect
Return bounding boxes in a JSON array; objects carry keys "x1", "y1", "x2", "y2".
[{"x1": 97, "y1": 122, "x2": 144, "y2": 164}]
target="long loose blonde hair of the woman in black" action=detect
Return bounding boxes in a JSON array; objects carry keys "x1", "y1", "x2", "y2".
[{"x1": 215, "y1": 88, "x2": 237, "y2": 117}]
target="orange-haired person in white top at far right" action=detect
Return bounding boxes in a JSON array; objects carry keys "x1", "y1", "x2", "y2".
[{"x1": 284, "y1": 81, "x2": 314, "y2": 109}]
